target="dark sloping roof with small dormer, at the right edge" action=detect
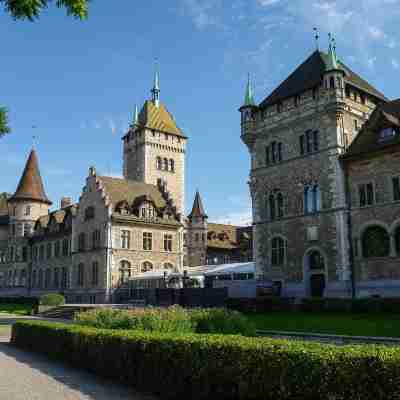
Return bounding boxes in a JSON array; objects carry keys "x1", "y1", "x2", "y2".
[{"x1": 342, "y1": 99, "x2": 400, "y2": 159}]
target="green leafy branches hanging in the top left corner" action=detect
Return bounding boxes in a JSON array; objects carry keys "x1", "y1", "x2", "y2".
[{"x1": 0, "y1": 0, "x2": 89, "y2": 21}]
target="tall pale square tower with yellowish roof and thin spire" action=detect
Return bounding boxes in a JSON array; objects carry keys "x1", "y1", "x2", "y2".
[{"x1": 123, "y1": 65, "x2": 187, "y2": 215}]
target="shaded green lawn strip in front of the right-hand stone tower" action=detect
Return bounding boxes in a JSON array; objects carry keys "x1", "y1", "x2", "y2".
[{"x1": 247, "y1": 312, "x2": 400, "y2": 337}]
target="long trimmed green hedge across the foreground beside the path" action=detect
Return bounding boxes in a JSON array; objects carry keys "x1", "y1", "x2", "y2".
[{"x1": 12, "y1": 321, "x2": 400, "y2": 400}]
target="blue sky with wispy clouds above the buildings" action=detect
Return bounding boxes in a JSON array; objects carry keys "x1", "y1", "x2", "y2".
[{"x1": 0, "y1": 0, "x2": 400, "y2": 223}]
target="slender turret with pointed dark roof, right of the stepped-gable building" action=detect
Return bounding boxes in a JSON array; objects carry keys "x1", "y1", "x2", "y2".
[{"x1": 187, "y1": 191, "x2": 208, "y2": 267}]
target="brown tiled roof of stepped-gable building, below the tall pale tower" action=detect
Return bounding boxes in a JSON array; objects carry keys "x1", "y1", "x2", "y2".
[{"x1": 99, "y1": 176, "x2": 166, "y2": 209}]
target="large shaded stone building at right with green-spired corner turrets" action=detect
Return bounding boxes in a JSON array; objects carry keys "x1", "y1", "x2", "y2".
[{"x1": 240, "y1": 39, "x2": 400, "y2": 297}]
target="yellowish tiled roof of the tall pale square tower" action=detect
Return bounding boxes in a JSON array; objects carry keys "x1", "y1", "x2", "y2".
[{"x1": 139, "y1": 100, "x2": 186, "y2": 138}]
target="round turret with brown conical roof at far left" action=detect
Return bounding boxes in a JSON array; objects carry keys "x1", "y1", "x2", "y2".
[{"x1": 8, "y1": 149, "x2": 52, "y2": 238}]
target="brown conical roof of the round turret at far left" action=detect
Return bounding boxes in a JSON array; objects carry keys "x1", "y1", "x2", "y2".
[{"x1": 10, "y1": 148, "x2": 52, "y2": 205}]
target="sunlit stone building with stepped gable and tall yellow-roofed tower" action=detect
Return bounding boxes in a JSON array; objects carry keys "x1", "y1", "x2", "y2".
[{"x1": 0, "y1": 68, "x2": 250, "y2": 303}]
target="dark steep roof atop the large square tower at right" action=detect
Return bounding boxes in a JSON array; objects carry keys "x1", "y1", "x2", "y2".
[{"x1": 260, "y1": 51, "x2": 386, "y2": 107}]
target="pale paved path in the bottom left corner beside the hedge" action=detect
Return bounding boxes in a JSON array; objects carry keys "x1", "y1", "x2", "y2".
[{"x1": 0, "y1": 318, "x2": 154, "y2": 400}]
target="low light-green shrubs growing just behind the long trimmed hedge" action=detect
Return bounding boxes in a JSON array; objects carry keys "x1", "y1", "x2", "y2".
[{"x1": 75, "y1": 306, "x2": 255, "y2": 335}]
